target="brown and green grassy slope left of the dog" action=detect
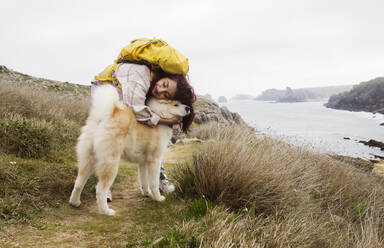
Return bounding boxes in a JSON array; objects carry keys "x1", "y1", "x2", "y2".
[{"x1": 0, "y1": 81, "x2": 91, "y2": 223}]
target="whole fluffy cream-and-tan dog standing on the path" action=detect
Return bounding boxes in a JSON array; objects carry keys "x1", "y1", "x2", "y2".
[{"x1": 69, "y1": 85, "x2": 190, "y2": 216}]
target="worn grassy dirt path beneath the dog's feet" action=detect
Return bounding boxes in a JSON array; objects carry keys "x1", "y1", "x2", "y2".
[{"x1": 0, "y1": 143, "x2": 198, "y2": 247}]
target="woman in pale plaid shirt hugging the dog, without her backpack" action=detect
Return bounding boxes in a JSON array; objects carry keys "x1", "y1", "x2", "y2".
[{"x1": 91, "y1": 63, "x2": 196, "y2": 194}]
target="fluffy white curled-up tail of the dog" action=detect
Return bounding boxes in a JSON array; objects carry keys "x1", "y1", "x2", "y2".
[{"x1": 90, "y1": 85, "x2": 122, "y2": 120}]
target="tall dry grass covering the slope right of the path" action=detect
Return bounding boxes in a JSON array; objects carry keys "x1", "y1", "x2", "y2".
[{"x1": 173, "y1": 124, "x2": 384, "y2": 247}]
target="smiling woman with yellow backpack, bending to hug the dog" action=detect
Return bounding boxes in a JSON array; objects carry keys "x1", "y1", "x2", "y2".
[{"x1": 91, "y1": 39, "x2": 196, "y2": 196}]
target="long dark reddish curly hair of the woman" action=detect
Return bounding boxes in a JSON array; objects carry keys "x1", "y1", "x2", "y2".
[{"x1": 147, "y1": 69, "x2": 196, "y2": 133}]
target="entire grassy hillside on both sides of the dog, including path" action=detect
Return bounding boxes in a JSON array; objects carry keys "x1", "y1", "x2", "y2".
[{"x1": 0, "y1": 67, "x2": 384, "y2": 248}]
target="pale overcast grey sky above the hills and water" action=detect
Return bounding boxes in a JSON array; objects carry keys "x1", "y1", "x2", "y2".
[{"x1": 0, "y1": 0, "x2": 384, "y2": 97}]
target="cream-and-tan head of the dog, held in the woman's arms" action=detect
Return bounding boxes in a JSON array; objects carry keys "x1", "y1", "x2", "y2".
[{"x1": 148, "y1": 98, "x2": 191, "y2": 119}]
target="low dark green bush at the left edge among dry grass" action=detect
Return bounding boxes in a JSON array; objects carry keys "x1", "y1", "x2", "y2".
[{"x1": 0, "y1": 120, "x2": 50, "y2": 158}]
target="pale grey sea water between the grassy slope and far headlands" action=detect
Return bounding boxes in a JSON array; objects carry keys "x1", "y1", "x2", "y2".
[{"x1": 220, "y1": 100, "x2": 384, "y2": 159}]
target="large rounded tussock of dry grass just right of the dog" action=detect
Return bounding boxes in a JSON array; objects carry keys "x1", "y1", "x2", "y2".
[{"x1": 173, "y1": 126, "x2": 295, "y2": 213}]
